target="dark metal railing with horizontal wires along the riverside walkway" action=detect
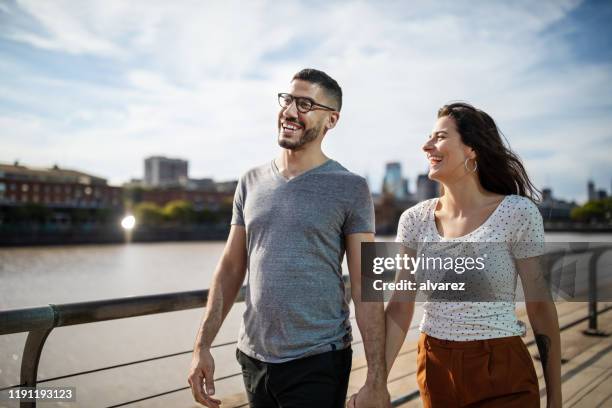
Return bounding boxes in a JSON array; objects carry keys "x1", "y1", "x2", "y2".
[{"x1": 0, "y1": 247, "x2": 612, "y2": 408}]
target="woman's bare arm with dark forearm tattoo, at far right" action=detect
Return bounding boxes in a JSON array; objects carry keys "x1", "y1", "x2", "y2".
[{"x1": 516, "y1": 257, "x2": 562, "y2": 408}]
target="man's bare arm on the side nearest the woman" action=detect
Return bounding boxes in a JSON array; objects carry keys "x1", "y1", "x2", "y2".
[{"x1": 346, "y1": 233, "x2": 390, "y2": 407}]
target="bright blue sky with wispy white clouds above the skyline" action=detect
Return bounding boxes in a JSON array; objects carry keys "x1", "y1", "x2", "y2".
[{"x1": 0, "y1": 0, "x2": 612, "y2": 201}]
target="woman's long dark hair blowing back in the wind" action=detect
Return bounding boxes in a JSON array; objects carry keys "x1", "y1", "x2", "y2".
[{"x1": 438, "y1": 102, "x2": 541, "y2": 201}]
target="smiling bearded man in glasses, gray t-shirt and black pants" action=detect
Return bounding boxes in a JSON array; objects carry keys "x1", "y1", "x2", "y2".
[{"x1": 189, "y1": 69, "x2": 389, "y2": 408}]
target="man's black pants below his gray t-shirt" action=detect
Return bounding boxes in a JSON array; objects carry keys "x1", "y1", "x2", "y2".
[{"x1": 236, "y1": 347, "x2": 353, "y2": 408}]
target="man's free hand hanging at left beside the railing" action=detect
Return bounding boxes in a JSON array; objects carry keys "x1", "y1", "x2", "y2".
[{"x1": 188, "y1": 348, "x2": 221, "y2": 408}]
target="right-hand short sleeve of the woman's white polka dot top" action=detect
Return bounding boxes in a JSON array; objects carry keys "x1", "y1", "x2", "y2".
[{"x1": 511, "y1": 198, "x2": 545, "y2": 259}]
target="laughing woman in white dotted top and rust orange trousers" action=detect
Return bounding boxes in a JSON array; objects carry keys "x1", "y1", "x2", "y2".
[{"x1": 386, "y1": 103, "x2": 561, "y2": 408}]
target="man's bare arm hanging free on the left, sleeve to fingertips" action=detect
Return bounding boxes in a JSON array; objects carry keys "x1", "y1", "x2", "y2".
[{"x1": 188, "y1": 225, "x2": 247, "y2": 408}]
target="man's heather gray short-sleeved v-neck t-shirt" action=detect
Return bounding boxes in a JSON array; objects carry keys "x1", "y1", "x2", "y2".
[{"x1": 232, "y1": 160, "x2": 374, "y2": 363}]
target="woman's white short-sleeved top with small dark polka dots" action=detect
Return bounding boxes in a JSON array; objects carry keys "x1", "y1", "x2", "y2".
[{"x1": 396, "y1": 195, "x2": 544, "y2": 341}]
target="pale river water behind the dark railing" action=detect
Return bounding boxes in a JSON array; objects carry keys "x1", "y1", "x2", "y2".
[{"x1": 0, "y1": 233, "x2": 612, "y2": 407}]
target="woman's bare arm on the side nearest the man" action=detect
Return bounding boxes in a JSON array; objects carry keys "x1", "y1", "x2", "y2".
[{"x1": 385, "y1": 248, "x2": 416, "y2": 376}]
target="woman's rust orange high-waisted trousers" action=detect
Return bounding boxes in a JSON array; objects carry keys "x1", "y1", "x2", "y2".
[{"x1": 417, "y1": 333, "x2": 540, "y2": 408}]
